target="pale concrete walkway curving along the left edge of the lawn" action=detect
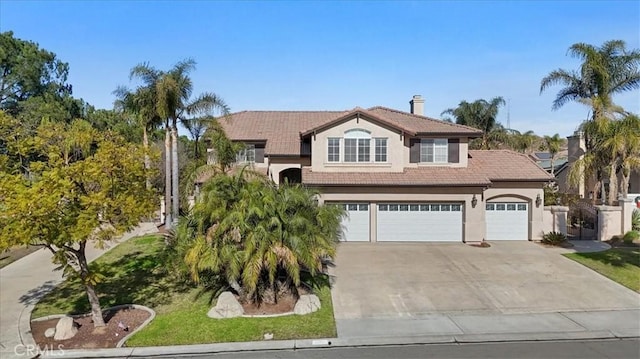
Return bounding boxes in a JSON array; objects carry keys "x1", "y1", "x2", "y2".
[{"x1": 0, "y1": 223, "x2": 157, "y2": 359}]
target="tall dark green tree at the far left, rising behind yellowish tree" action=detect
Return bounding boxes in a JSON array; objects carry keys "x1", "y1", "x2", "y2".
[{"x1": 0, "y1": 31, "x2": 71, "y2": 116}]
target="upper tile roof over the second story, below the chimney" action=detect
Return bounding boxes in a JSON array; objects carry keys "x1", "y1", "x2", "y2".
[{"x1": 220, "y1": 107, "x2": 482, "y2": 156}]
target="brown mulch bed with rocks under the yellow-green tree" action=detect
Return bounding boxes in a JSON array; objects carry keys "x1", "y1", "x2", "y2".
[{"x1": 31, "y1": 308, "x2": 151, "y2": 349}]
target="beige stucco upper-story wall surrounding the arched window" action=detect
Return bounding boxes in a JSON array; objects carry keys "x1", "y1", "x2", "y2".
[{"x1": 311, "y1": 117, "x2": 469, "y2": 172}]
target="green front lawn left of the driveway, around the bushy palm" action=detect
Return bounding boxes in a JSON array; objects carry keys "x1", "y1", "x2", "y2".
[{"x1": 32, "y1": 236, "x2": 336, "y2": 346}]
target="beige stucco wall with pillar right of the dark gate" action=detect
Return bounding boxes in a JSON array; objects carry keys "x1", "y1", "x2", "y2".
[{"x1": 596, "y1": 198, "x2": 636, "y2": 241}]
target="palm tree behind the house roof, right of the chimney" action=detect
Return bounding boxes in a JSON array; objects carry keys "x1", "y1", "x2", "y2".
[{"x1": 441, "y1": 96, "x2": 506, "y2": 150}]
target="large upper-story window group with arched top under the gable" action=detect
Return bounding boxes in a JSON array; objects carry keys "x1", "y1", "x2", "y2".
[{"x1": 327, "y1": 129, "x2": 388, "y2": 163}]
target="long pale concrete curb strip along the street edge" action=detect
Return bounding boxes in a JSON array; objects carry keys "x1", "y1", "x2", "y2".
[{"x1": 43, "y1": 331, "x2": 639, "y2": 358}]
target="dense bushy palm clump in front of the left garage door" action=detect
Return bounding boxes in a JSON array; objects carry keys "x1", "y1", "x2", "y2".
[{"x1": 173, "y1": 176, "x2": 343, "y2": 303}]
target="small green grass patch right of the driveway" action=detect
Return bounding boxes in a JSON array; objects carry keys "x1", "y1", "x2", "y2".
[{"x1": 565, "y1": 248, "x2": 640, "y2": 292}]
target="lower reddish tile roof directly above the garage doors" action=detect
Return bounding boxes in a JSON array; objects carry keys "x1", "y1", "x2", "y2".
[{"x1": 302, "y1": 150, "x2": 552, "y2": 186}]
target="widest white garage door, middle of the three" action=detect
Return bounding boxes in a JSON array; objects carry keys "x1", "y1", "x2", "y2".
[{"x1": 377, "y1": 203, "x2": 462, "y2": 242}]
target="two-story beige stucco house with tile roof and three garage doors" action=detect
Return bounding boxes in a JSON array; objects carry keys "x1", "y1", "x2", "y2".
[{"x1": 214, "y1": 96, "x2": 551, "y2": 242}]
